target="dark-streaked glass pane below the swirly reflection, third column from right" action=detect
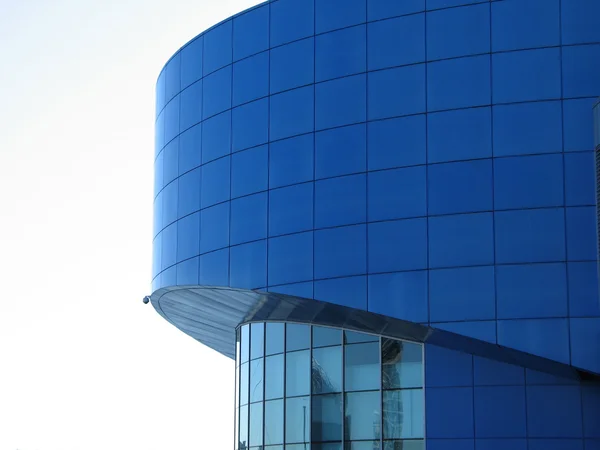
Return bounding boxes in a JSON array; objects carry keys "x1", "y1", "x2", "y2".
[{"x1": 311, "y1": 394, "x2": 342, "y2": 442}]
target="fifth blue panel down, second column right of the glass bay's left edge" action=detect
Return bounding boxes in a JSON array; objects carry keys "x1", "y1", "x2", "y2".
[{"x1": 269, "y1": 183, "x2": 313, "y2": 236}]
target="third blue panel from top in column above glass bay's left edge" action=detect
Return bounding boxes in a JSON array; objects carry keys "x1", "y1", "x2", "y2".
[{"x1": 233, "y1": 98, "x2": 269, "y2": 152}]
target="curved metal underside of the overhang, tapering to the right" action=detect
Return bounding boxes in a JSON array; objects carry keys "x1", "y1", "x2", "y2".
[{"x1": 150, "y1": 286, "x2": 600, "y2": 381}]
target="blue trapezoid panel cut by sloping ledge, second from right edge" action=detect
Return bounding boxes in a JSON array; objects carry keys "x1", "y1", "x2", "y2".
[{"x1": 498, "y1": 319, "x2": 569, "y2": 364}]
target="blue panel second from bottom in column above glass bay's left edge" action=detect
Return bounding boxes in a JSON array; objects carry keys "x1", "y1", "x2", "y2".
[{"x1": 230, "y1": 192, "x2": 267, "y2": 246}]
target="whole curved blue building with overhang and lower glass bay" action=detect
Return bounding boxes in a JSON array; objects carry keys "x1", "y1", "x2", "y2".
[{"x1": 151, "y1": 0, "x2": 600, "y2": 450}]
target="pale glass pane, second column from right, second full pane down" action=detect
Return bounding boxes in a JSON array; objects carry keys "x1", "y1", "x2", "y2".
[{"x1": 344, "y1": 391, "x2": 381, "y2": 440}]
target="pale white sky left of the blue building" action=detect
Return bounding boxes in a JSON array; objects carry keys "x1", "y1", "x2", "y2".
[{"x1": 0, "y1": 0, "x2": 259, "y2": 450}]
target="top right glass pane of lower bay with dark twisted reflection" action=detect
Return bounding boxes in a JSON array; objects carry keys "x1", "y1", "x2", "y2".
[{"x1": 381, "y1": 339, "x2": 423, "y2": 389}]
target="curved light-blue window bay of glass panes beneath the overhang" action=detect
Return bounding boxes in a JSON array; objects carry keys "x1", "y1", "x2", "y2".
[{"x1": 235, "y1": 322, "x2": 425, "y2": 450}]
